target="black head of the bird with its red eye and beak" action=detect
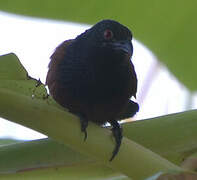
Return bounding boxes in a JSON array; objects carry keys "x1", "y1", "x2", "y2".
[{"x1": 78, "y1": 20, "x2": 133, "y2": 56}]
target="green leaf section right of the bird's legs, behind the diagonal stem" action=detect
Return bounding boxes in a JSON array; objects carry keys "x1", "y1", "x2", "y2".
[{"x1": 123, "y1": 110, "x2": 197, "y2": 165}]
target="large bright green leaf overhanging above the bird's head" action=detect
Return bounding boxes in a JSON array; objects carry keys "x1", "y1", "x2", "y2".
[{"x1": 0, "y1": 0, "x2": 197, "y2": 90}]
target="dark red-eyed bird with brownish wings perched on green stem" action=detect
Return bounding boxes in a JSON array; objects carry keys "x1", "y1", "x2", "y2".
[{"x1": 46, "y1": 19, "x2": 139, "y2": 161}]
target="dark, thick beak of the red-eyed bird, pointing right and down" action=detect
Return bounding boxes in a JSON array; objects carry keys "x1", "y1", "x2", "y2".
[{"x1": 112, "y1": 41, "x2": 133, "y2": 55}]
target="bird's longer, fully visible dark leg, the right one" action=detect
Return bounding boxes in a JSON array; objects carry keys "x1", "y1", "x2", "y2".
[{"x1": 109, "y1": 120, "x2": 122, "y2": 161}]
